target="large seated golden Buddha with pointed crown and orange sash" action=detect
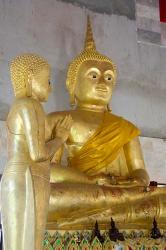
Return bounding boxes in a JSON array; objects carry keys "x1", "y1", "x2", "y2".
[{"x1": 47, "y1": 19, "x2": 166, "y2": 230}]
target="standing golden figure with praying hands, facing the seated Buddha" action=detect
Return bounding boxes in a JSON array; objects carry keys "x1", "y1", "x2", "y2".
[{"x1": 1, "y1": 54, "x2": 72, "y2": 250}]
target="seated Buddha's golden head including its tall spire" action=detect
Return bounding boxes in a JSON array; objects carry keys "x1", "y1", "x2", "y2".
[{"x1": 66, "y1": 17, "x2": 116, "y2": 105}]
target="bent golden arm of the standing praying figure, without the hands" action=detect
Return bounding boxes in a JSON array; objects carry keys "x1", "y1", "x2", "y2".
[{"x1": 20, "y1": 101, "x2": 62, "y2": 162}]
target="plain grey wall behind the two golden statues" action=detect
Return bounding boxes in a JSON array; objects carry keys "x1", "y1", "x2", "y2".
[{"x1": 0, "y1": 0, "x2": 166, "y2": 181}]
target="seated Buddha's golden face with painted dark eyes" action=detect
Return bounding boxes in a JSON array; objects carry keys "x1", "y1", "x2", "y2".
[{"x1": 75, "y1": 60, "x2": 115, "y2": 105}]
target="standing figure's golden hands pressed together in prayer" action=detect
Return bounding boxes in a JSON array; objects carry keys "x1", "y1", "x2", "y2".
[{"x1": 53, "y1": 115, "x2": 73, "y2": 142}]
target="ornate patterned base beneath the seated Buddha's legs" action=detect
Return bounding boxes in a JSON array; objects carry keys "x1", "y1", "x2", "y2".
[{"x1": 44, "y1": 230, "x2": 166, "y2": 250}]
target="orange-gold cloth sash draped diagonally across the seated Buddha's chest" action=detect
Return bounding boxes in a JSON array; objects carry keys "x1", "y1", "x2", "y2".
[{"x1": 69, "y1": 112, "x2": 140, "y2": 176}]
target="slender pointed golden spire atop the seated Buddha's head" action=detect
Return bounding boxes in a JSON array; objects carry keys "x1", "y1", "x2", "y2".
[{"x1": 85, "y1": 16, "x2": 96, "y2": 50}]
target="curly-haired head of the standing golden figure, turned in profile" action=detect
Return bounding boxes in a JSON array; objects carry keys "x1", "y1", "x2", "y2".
[{"x1": 10, "y1": 54, "x2": 51, "y2": 102}]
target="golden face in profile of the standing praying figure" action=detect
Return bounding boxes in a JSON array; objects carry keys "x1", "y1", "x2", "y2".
[{"x1": 31, "y1": 67, "x2": 51, "y2": 102}]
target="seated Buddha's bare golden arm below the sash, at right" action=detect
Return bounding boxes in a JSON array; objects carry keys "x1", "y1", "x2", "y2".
[{"x1": 122, "y1": 137, "x2": 149, "y2": 186}]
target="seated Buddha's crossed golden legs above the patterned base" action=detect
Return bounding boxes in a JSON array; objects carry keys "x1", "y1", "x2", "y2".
[{"x1": 48, "y1": 183, "x2": 166, "y2": 229}]
